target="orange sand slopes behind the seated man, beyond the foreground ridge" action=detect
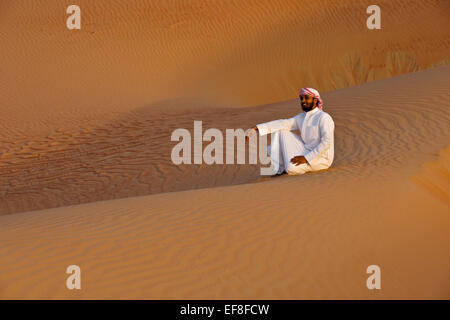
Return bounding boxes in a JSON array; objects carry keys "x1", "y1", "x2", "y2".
[{"x1": 0, "y1": 0, "x2": 450, "y2": 214}]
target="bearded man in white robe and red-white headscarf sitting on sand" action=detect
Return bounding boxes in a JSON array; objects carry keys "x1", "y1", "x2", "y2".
[{"x1": 252, "y1": 88, "x2": 334, "y2": 175}]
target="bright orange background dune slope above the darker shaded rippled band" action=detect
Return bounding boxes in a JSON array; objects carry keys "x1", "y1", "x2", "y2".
[{"x1": 0, "y1": 0, "x2": 450, "y2": 134}]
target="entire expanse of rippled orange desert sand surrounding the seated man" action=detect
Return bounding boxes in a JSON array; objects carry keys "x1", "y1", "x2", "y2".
[{"x1": 0, "y1": 0, "x2": 450, "y2": 299}]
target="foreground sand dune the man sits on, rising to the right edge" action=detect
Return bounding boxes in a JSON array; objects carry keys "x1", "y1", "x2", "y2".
[{"x1": 0, "y1": 67, "x2": 450, "y2": 299}]
